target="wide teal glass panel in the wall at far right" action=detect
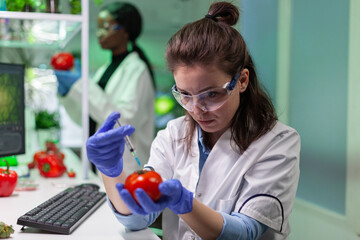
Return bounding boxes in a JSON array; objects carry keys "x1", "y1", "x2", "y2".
[{"x1": 290, "y1": 0, "x2": 349, "y2": 215}]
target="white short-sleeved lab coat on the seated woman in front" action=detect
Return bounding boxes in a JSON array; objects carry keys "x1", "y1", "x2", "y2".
[{"x1": 147, "y1": 117, "x2": 300, "y2": 240}]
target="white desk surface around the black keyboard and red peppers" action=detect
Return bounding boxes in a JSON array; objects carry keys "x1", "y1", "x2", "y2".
[{"x1": 0, "y1": 150, "x2": 159, "y2": 240}]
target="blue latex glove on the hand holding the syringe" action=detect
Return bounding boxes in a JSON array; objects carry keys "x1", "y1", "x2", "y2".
[{"x1": 86, "y1": 112, "x2": 135, "y2": 177}]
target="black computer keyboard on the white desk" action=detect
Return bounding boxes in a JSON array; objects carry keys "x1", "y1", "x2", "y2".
[{"x1": 17, "y1": 184, "x2": 106, "y2": 234}]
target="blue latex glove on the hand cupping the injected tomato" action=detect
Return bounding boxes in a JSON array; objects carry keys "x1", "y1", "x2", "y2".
[{"x1": 116, "y1": 179, "x2": 193, "y2": 215}]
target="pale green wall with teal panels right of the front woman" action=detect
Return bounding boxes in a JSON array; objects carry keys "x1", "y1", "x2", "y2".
[{"x1": 241, "y1": 0, "x2": 360, "y2": 240}]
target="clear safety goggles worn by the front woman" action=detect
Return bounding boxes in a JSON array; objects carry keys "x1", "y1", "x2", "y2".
[{"x1": 171, "y1": 74, "x2": 240, "y2": 112}]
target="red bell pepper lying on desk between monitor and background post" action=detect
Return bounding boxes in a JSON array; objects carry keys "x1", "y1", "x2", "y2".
[{"x1": 37, "y1": 152, "x2": 66, "y2": 178}]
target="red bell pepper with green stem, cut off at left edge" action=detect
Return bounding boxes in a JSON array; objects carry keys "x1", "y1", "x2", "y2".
[{"x1": 0, "y1": 159, "x2": 17, "y2": 197}]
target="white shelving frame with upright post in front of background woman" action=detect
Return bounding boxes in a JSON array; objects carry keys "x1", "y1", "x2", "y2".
[{"x1": 0, "y1": 0, "x2": 89, "y2": 179}]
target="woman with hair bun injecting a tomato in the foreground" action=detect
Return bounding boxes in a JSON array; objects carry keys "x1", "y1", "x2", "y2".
[{"x1": 87, "y1": 2, "x2": 300, "y2": 240}]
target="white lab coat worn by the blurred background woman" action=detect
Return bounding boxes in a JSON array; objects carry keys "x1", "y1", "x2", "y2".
[{"x1": 61, "y1": 52, "x2": 155, "y2": 173}]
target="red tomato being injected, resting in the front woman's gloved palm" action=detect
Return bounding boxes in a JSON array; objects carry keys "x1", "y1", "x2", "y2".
[{"x1": 124, "y1": 170, "x2": 162, "y2": 201}]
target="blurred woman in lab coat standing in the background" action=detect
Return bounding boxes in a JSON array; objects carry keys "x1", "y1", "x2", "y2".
[{"x1": 55, "y1": 2, "x2": 155, "y2": 174}]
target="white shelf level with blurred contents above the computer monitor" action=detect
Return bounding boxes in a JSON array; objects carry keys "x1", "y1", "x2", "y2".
[{"x1": 0, "y1": 11, "x2": 82, "y2": 49}]
